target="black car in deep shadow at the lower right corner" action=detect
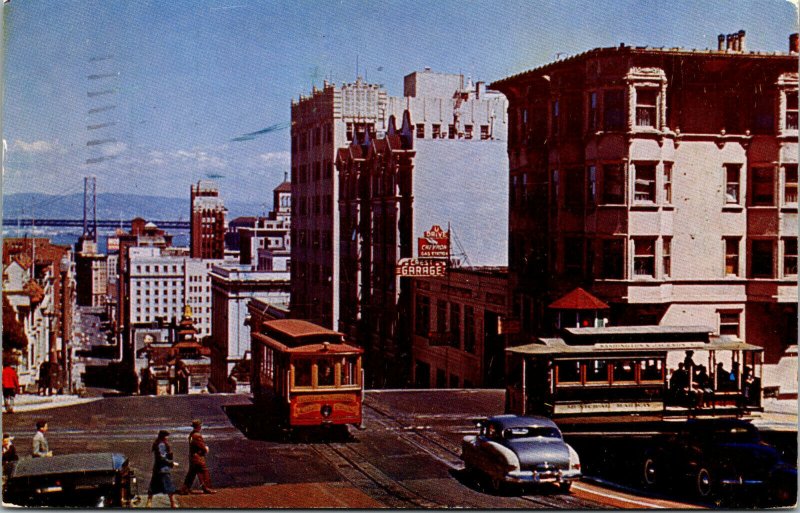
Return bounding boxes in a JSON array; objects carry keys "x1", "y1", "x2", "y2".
[{"x1": 642, "y1": 419, "x2": 797, "y2": 504}]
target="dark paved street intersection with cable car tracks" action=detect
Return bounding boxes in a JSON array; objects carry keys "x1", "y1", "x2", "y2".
[{"x1": 3, "y1": 390, "x2": 720, "y2": 509}]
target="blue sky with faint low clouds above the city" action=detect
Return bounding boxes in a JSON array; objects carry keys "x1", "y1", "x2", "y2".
[{"x1": 0, "y1": 0, "x2": 798, "y2": 208}]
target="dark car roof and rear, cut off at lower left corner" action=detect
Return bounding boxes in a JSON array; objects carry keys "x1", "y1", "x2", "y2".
[{"x1": 3, "y1": 452, "x2": 137, "y2": 507}]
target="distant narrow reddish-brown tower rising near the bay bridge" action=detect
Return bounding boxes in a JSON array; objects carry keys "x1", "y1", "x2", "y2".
[{"x1": 189, "y1": 180, "x2": 226, "y2": 258}]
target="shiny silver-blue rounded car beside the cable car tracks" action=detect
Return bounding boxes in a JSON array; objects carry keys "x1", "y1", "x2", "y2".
[{"x1": 461, "y1": 415, "x2": 581, "y2": 492}]
